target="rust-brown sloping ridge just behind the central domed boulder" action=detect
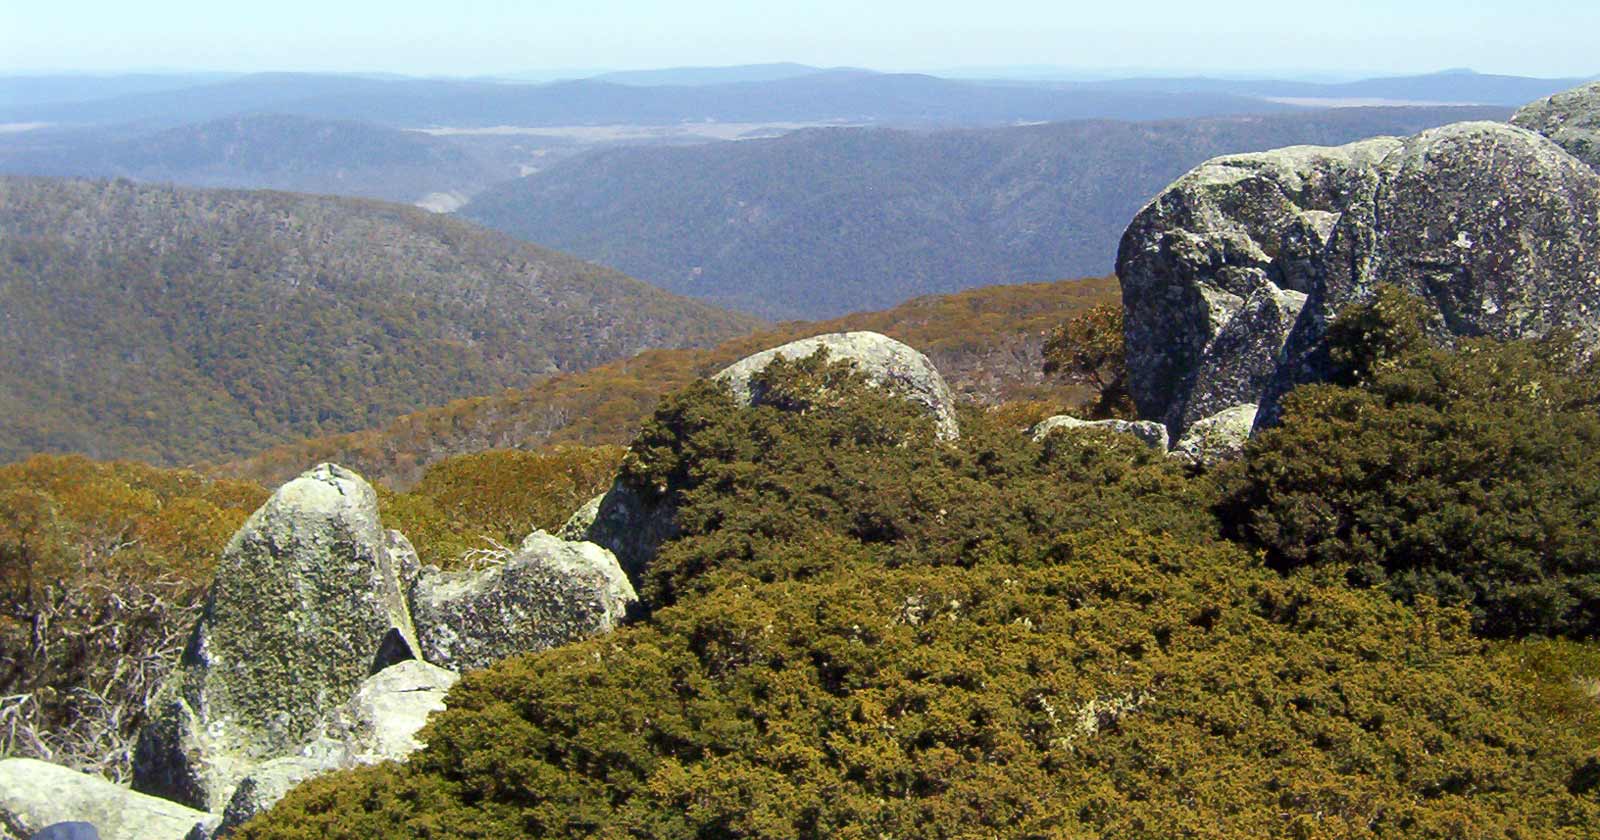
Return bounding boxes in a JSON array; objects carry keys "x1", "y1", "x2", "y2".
[{"x1": 214, "y1": 277, "x2": 1118, "y2": 488}]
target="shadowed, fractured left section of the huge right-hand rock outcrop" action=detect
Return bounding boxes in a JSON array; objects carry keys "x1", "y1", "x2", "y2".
[{"x1": 1117, "y1": 138, "x2": 1402, "y2": 434}]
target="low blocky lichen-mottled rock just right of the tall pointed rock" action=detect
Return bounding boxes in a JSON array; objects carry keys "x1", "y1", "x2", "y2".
[{"x1": 411, "y1": 531, "x2": 637, "y2": 670}]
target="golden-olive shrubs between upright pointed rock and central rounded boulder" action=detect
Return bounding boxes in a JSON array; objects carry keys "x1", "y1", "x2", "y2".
[{"x1": 378, "y1": 446, "x2": 622, "y2": 568}]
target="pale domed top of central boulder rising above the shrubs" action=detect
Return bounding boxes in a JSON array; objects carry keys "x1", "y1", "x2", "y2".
[{"x1": 714, "y1": 331, "x2": 962, "y2": 440}]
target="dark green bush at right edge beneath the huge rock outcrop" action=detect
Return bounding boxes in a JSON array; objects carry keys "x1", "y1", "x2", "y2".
[{"x1": 1221, "y1": 293, "x2": 1600, "y2": 637}]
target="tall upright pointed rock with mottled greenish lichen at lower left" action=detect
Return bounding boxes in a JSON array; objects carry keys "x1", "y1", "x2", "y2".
[{"x1": 134, "y1": 464, "x2": 416, "y2": 811}]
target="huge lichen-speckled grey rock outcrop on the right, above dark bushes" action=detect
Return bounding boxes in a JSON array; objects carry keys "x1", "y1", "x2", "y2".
[{"x1": 1117, "y1": 116, "x2": 1600, "y2": 437}]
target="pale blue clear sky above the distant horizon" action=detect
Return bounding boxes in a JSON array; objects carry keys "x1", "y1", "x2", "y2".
[{"x1": 0, "y1": 0, "x2": 1600, "y2": 77}]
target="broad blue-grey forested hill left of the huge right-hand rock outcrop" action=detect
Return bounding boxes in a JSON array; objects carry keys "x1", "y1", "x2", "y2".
[{"x1": 461, "y1": 109, "x2": 1507, "y2": 318}]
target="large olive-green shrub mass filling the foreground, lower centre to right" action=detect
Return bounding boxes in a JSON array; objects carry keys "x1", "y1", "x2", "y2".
[{"x1": 240, "y1": 357, "x2": 1600, "y2": 840}]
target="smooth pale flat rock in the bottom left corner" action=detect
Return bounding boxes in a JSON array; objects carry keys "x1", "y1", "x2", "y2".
[{"x1": 0, "y1": 758, "x2": 211, "y2": 840}]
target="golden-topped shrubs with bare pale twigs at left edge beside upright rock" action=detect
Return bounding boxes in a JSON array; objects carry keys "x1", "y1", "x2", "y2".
[{"x1": 0, "y1": 456, "x2": 266, "y2": 778}]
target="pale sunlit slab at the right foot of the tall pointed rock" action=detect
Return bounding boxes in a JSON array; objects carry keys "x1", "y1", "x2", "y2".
[{"x1": 211, "y1": 659, "x2": 461, "y2": 838}]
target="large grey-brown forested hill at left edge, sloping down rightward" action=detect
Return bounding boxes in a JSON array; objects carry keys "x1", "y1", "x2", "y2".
[{"x1": 0, "y1": 178, "x2": 757, "y2": 464}]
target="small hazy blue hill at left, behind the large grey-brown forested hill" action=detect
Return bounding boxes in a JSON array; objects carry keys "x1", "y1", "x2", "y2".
[{"x1": 0, "y1": 114, "x2": 515, "y2": 203}]
